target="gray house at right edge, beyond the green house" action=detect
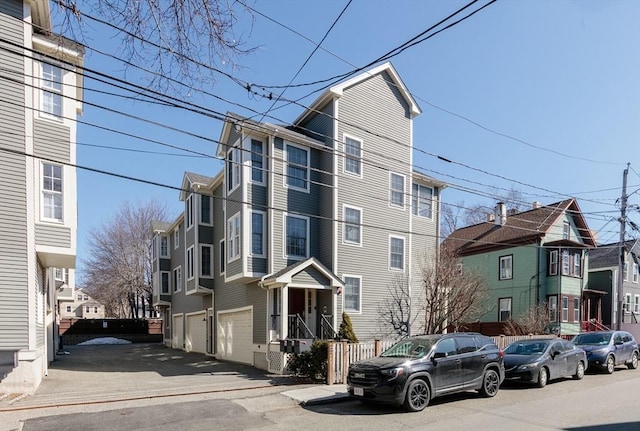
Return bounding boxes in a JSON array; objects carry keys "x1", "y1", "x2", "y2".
[{"x1": 588, "y1": 239, "x2": 640, "y2": 336}]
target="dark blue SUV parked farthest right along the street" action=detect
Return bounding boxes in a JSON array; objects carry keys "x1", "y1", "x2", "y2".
[{"x1": 573, "y1": 331, "x2": 640, "y2": 374}]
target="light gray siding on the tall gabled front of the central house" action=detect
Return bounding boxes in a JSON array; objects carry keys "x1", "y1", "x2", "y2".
[{"x1": 335, "y1": 73, "x2": 412, "y2": 339}]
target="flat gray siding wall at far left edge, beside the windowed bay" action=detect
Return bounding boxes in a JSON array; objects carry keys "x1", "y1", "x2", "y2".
[{"x1": 0, "y1": 0, "x2": 29, "y2": 349}]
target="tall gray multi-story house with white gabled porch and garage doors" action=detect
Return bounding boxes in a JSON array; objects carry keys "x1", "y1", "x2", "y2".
[{"x1": 152, "y1": 63, "x2": 445, "y2": 371}]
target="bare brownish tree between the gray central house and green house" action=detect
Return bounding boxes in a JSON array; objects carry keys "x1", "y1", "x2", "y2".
[{"x1": 422, "y1": 247, "x2": 489, "y2": 334}]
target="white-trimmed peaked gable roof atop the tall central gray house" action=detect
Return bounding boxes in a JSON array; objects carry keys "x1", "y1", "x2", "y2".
[{"x1": 293, "y1": 62, "x2": 422, "y2": 125}]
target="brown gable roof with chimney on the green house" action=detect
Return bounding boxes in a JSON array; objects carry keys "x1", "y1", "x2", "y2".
[{"x1": 443, "y1": 199, "x2": 596, "y2": 256}]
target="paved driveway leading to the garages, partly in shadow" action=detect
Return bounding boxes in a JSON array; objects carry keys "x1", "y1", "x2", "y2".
[{"x1": 0, "y1": 344, "x2": 292, "y2": 411}]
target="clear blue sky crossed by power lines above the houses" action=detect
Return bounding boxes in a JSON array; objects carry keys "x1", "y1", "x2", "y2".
[{"x1": 56, "y1": 0, "x2": 640, "y2": 277}]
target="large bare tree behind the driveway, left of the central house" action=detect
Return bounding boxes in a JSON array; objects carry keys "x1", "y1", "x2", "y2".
[{"x1": 83, "y1": 200, "x2": 166, "y2": 318}]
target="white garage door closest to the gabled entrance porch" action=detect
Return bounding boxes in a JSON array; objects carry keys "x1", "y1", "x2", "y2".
[{"x1": 216, "y1": 310, "x2": 253, "y2": 365}]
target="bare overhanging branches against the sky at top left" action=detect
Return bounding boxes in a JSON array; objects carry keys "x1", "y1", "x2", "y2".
[{"x1": 53, "y1": 0, "x2": 255, "y2": 88}]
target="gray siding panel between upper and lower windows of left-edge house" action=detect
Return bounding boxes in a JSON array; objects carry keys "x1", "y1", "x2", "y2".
[{"x1": 33, "y1": 119, "x2": 72, "y2": 163}]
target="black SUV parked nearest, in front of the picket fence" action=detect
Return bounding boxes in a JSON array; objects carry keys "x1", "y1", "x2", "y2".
[{"x1": 347, "y1": 332, "x2": 504, "y2": 412}]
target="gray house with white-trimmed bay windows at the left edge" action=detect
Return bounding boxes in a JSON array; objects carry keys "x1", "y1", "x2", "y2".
[{"x1": 0, "y1": 0, "x2": 84, "y2": 393}]
